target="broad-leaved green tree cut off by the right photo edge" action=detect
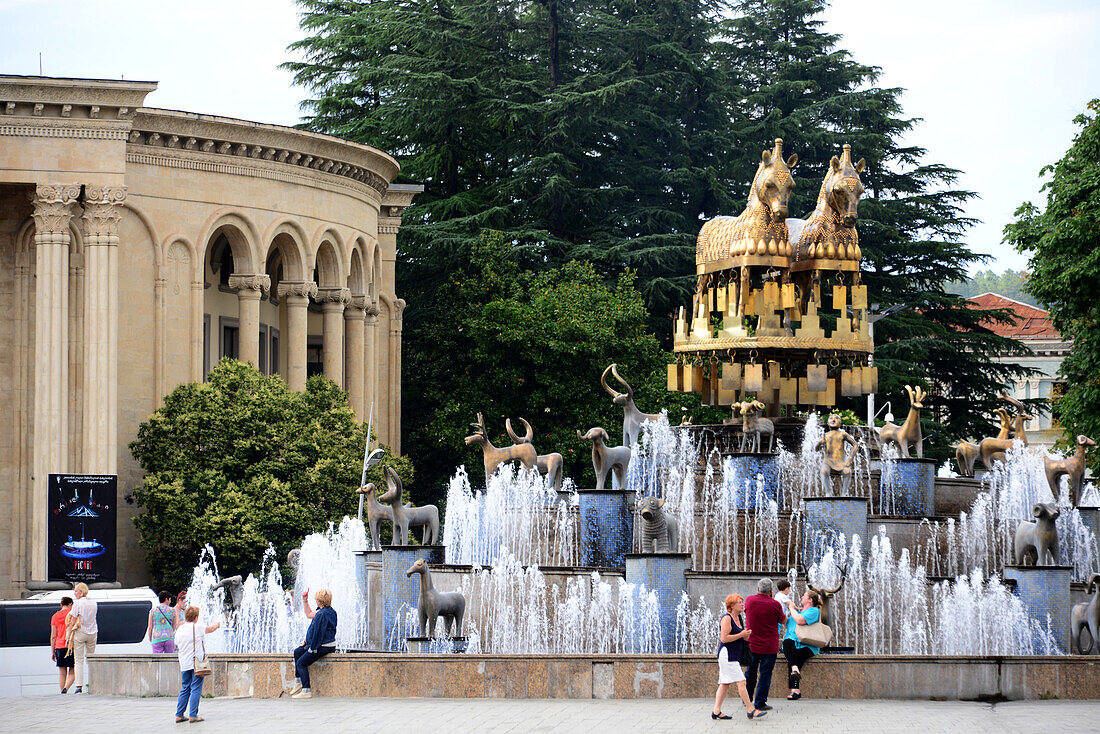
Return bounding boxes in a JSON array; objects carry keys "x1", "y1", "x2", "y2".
[{"x1": 1004, "y1": 99, "x2": 1100, "y2": 471}]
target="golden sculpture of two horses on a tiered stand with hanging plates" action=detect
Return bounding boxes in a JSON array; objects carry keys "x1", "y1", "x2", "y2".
[{"x1": 669, "y1": 139, "x2": 878, "y2": 415}]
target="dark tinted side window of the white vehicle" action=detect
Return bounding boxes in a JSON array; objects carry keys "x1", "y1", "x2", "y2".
[{"x1": 0, "y1": 600, "x2": 153, "y2": 647}]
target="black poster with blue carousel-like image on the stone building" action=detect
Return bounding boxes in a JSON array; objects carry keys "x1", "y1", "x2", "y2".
[{"x1": 46, "y1": 474, "x2": 118, "y2": 583}]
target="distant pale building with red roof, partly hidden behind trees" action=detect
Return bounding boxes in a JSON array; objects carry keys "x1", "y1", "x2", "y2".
[{"x1": 967, "y1": 293, "x2": 1073, "y2": 447}]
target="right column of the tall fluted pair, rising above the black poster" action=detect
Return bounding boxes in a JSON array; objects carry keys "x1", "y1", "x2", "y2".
[{"x1": 84, "y1": 180, "x2": 127, "y2": 474}]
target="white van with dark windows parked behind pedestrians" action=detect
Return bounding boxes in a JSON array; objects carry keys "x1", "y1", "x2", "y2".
[{"x1": 0, "y1": 587, "x2": 157, "y2": 697}]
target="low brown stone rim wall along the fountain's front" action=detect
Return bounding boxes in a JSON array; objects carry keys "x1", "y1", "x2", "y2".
[{"x1": 89, "y1": 653, "x2": 1100, "y2": 700}]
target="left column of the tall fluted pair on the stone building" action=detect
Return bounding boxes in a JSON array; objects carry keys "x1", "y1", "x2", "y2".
[{"x1": 30, "y1": 179, "x2": 80, "y2": 580}]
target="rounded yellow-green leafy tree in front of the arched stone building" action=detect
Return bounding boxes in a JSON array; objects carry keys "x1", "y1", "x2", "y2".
[{"x1": 130, "y1": 359, "x2": 413, "y2": 588}]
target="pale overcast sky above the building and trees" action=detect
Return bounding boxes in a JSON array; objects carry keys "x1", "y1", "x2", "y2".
[{"x1": 0, "y1": 0, "x2": 1100, "y2": 271}]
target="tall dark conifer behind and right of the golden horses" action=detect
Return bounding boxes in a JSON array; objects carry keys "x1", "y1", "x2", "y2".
[{"x1": 732, "y1": 0, "x2": 1026, "y2": 460}]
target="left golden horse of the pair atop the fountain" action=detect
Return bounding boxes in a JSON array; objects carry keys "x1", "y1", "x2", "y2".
[{"x1": 695, "y1": 138, "x2": 799, "y2": 293}]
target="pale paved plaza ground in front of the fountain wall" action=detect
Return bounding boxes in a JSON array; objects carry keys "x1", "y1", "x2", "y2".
[{"x1": 0, "y1": 694, "x2": 1100, "y2": 734}]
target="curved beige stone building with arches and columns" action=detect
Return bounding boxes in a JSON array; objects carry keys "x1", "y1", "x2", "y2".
[{"x1": 0, "y1": 76, "x2": 421, "y2": 596}]
